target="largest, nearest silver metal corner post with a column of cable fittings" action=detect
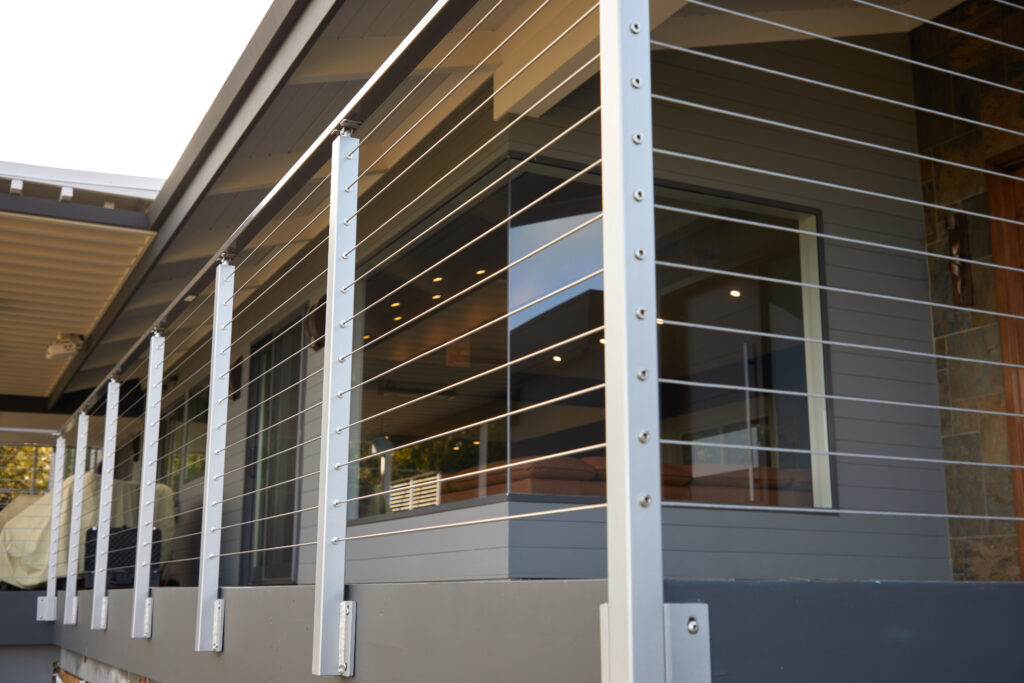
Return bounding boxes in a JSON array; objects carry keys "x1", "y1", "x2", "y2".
[{"x1": 600, "y1": 0, "x2": 666, "y2": 683}]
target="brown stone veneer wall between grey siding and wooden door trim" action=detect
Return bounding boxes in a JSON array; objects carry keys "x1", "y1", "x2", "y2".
[{"x1": 910, "y1": 0, "x2": 1024, "y2": 581}]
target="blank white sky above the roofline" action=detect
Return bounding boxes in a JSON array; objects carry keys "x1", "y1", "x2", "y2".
[{"x1": 0, "y1": 0, "x2": 271, "y2": 178}]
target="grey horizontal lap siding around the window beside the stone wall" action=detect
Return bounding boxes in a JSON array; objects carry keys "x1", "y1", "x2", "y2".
[{"x1": 511, "y1": 37, "x2": 950, "y2": 580}]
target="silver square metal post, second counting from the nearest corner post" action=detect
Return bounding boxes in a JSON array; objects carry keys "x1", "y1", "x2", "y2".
[{"x1": 312, "y1": 130, "x2": 359, "y2": 676}]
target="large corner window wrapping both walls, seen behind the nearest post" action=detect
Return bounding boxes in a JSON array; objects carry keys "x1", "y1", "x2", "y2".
[{"x1": 352, "y1": 164, "x2": 831, "y2": 516}]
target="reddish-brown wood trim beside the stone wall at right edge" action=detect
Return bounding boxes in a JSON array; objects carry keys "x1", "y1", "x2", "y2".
[{"x1": 987, "y1": 145, "x2": 1024, "y2": 577}]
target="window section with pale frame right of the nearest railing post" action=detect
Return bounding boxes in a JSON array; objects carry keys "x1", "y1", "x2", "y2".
[{"x1": 656, "y1": 187, "x2": 831, "y2": 507}]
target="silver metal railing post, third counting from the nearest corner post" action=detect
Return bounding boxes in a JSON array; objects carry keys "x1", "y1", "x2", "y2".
[{"x1": 196, "y1": 259, "x2": 234, "y2": 652}]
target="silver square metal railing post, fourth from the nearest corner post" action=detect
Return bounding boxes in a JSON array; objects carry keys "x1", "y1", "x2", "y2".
[{"x1": 131, "y1": 332, "x2": 164, "y2": 638}]
